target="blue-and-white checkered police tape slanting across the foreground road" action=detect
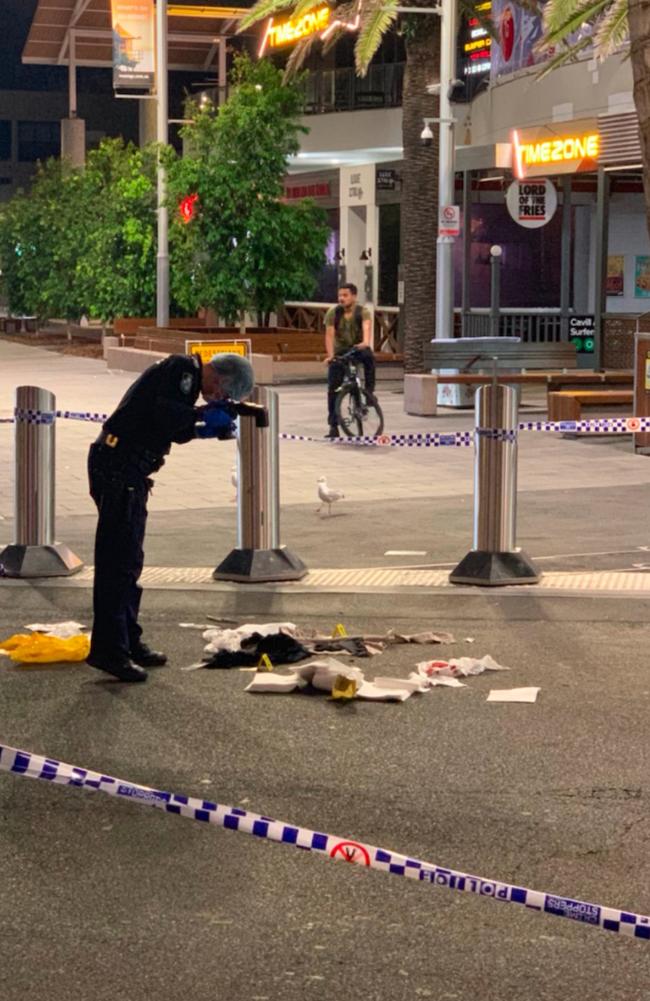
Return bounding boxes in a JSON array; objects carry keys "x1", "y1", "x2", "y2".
[{"x1": 0, "y1": 744, "x2": 650, "y2": 940}]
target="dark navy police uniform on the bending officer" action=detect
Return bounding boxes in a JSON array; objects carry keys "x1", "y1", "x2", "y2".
[{"x1": 88, "y1": 354, "x2": 201, "y2": 663}]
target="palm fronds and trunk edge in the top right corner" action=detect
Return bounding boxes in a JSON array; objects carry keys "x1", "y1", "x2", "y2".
[{"x1": 540, "y1": 0, "x2": 650, "y2": 231}]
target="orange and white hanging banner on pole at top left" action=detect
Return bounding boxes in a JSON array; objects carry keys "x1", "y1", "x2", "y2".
[{"x1": 111, "y1": 0, "x2": 155, "y2": 90}]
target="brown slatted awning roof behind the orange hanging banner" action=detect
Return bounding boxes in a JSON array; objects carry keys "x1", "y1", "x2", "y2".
[{"x1": 22, "y1": 0, "x2": 252, "y2": 72}]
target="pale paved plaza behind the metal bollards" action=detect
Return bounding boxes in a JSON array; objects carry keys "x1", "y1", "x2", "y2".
[{"x1": 0, "y1": 340, "x2": 650, "y2": 520}]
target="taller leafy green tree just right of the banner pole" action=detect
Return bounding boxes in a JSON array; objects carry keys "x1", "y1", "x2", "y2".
[{"x1": 167, "y1": 56, "x2": 328, "y2": 322}]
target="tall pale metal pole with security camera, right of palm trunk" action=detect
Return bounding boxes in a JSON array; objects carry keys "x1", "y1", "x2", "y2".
[{"x1": 436, "y1": 0, "x2": 456, "y2": 337}]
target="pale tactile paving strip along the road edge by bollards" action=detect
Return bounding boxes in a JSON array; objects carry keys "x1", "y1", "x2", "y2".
[{"x1": 64, "y1": 567, "x2": 650, "y2": 594}]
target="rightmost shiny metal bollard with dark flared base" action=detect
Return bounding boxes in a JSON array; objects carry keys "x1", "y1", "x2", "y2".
[{"x1": 449, "y1": 381, "x2": 540, "y2": 587}]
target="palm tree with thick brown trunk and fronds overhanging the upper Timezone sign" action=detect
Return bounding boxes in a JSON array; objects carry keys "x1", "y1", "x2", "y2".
[{"x1": 239, "y1": 0, "x2": 440, "y2": 371}]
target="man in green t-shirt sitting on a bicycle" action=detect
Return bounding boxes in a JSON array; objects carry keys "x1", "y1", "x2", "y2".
[{"x1": 324, "y1": 281, "x2": 375, "y2": 437}]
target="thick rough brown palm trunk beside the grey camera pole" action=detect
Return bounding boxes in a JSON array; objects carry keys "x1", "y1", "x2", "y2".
[{"x1": 402, "y1": 14, "x2": 440, "y2": 372}]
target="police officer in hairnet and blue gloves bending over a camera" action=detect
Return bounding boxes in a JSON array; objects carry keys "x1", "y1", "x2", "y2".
[{"x1": 87, "y1": 354, "x2": 254, "y2": 682}]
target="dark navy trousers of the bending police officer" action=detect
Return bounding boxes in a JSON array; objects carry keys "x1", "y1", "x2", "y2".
[{"x1": 88, "y1": 442, "x2": 153, "y2": 660}]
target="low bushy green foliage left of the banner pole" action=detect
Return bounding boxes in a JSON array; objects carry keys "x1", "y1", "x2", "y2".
[{"x1": 0, "y1": 139, "x2": 156, "y2": 319}]
